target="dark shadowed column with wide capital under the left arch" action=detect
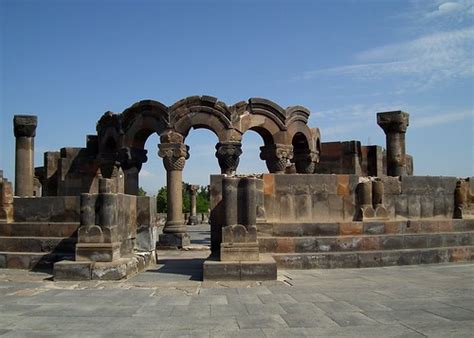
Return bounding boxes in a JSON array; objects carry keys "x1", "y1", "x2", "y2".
[{"x1": 119, "y1": 148, "x2": 148, "y2": 196}]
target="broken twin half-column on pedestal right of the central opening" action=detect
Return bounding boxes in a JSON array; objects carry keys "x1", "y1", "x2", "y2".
[{"x1": 220, "y1": 177, "x2": 259, "y2": 262}]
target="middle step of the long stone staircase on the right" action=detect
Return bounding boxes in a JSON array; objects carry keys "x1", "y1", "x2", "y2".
[{"x1": 258, "y1": 231, "x2": 474, "y2": 253}]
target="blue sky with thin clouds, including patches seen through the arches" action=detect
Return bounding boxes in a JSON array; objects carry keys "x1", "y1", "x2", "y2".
[{"x1": 0, "y1": 0, "x2": 474, "y2": 194}]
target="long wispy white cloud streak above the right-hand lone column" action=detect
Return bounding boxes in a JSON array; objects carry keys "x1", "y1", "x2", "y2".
[{"x1": 300, "y1": 27, "x2": 474, "y2": 90}]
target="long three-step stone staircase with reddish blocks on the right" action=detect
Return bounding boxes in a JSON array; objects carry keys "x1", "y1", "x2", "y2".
[{"x1": 258, "y1": 219, "x2": 474, "y2": 269}]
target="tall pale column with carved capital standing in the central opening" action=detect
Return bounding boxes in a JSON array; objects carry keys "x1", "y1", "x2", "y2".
[{"x1": 158, "y1": 143, "x2": 190, "y2": 248}]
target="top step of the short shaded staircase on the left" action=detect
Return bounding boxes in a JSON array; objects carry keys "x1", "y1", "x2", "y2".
[{"x1": 0, "y1": 222, "x2": 80, "y2": 237}]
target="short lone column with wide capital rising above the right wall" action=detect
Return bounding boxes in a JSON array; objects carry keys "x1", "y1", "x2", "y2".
[{"x1": 377, "y1": 111, "x2": 409, "y2": 176}]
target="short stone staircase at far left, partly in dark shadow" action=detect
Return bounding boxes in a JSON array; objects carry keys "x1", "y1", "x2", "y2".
[{"x1": 0, "y1": 221, "x2": 79, "y2": 269}]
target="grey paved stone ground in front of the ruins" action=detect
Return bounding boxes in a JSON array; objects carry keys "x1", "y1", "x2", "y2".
[{"x1": 0, "y1": 223, "x2": 474, "y2": 338}]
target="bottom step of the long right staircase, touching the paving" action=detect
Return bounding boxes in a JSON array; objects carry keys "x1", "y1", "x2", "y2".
[{"x1": 272, "y1": 246, "x2": 474, "y2": 269}]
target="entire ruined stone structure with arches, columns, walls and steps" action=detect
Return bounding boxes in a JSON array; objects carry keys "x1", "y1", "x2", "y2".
[{"x1": 0, "y1": 96, "x2": 474, "y2": 280}]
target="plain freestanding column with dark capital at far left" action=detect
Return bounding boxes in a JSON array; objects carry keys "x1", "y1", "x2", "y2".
[{"x1": 13, "y1": 115, "x2": 38, "y2": 197}]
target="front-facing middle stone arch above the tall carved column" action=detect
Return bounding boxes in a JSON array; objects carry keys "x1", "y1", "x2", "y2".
[{"x1": 169, "y1": 96, "x2": 236, "y2": 142}]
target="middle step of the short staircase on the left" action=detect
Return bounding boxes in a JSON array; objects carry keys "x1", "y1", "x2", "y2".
[{"x1": 0, "y1": 236, "x2": 77, "y2": 252}]
